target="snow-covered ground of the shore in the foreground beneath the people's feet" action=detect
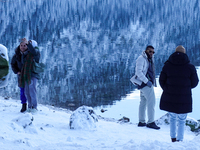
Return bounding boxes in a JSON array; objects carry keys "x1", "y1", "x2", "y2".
[{"x1": 0, "y1": 97, "x2": 200, "y2": 150}]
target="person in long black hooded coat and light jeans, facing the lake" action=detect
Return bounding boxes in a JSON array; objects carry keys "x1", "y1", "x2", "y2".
[{"x1": 159, "y1": 45, "x2": 199, "y2": 142}]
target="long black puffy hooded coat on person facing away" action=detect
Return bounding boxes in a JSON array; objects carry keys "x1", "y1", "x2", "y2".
[{"x1": 159, "y1": 52, "x2": 199, "y2": 114}]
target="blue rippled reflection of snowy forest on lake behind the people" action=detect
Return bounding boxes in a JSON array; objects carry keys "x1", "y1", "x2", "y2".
[{"x1": 0, "y1": 0, "x2": 200, "y2": 110}]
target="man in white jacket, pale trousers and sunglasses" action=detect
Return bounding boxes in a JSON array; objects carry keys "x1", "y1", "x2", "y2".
[{"x1": 131, "y1": 45, "x2": 160, "y2": 129}]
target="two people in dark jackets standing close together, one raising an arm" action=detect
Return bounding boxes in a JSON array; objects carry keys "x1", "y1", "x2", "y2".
[{"x1": 11, "y1": 38, "x2": 40, "y2": 112}]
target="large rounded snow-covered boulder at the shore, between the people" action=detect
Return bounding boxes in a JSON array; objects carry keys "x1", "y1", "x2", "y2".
[{"x1": 69, "y1": 106, "x2": 98, "y2": 130}]
